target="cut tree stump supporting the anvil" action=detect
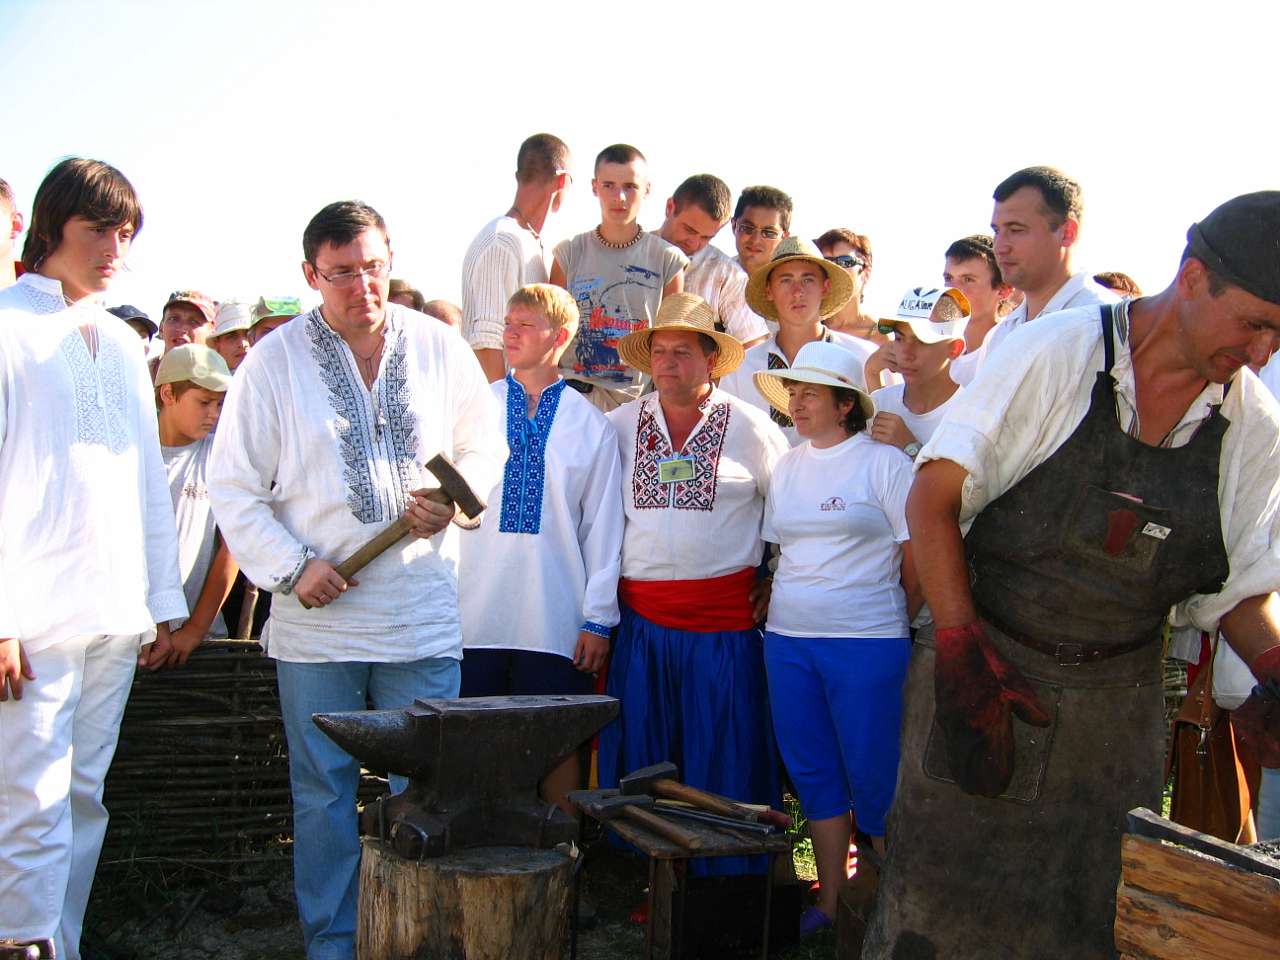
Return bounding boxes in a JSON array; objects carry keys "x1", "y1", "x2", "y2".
[{"x1": 356, "y1": 837, "x2": 573, "y2": 960}]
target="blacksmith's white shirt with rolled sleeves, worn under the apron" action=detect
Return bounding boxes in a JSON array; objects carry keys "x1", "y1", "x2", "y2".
[{"x1": 916, "y1": 296, "x2": 1280, "y2": 631}]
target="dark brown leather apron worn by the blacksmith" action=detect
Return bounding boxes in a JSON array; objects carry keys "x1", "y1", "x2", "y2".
[{"x1": 863, "y1": 306, "x2": 1228, "y2": 960}]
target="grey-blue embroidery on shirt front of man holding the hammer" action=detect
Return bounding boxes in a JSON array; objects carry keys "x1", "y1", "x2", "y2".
[{"x1": 306, "y1": 310, "x2": 421, "y2": 524}]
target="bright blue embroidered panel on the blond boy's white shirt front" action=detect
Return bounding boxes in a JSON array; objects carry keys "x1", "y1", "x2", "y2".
[{"x1": 498, "y1": 374, "x2": 566, "y2": 534}]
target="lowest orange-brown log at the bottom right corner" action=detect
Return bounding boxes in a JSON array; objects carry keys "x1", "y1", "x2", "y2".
[{"x1": 1115, "y1": 883, "x2": 1280, "y2": 960}]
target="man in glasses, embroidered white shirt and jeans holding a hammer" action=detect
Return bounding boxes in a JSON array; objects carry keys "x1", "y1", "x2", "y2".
[{"x1": 209, "y1": 201, "x2": 507, "y2": 960}]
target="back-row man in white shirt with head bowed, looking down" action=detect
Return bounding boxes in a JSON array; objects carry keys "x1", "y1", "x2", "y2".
[{"x1": 658, "y1": 173, "x2": 769, "y2": 347}]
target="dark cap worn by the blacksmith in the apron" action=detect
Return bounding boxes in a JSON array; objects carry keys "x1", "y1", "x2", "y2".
[{"x1": 1187, "y1": 189, "x2": 1280, "y2": 303}]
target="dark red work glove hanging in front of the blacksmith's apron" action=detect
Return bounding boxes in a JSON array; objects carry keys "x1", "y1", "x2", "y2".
[{"x1": 933, "y1": 623, "x2": 1050, "y2": 796}]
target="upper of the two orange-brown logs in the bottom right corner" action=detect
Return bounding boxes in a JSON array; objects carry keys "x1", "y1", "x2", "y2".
[{"x1": 1120, "y1": 835, "x2": 1280, "y2": 945}]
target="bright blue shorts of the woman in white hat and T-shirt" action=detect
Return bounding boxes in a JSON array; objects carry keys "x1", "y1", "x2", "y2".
[{"x1": 764, "y1": 631, "x2": 911, "y2": 837}]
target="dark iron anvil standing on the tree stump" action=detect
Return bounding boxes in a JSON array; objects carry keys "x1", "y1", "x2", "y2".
[{"x1": 312, "y1": 696, "x2": 618, "y2": 860}]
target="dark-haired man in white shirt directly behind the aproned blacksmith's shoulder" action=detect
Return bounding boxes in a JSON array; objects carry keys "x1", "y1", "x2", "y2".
[{"x1": 952, "y1": 166, "x2": 1116, "y2": 387}]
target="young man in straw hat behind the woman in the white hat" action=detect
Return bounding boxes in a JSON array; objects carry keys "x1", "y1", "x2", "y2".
[{"x1": 721, "y1": 237, "x2": 876, "y2": 447}]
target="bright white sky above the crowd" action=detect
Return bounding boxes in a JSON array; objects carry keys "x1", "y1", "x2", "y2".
[{"x1": 0, "y1": 0, "x2": 1280, "y2": 323}]
